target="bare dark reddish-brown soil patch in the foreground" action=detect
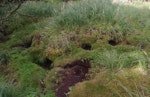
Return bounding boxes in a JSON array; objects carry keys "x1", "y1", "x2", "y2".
[{"x1": 54, "y1": 60, "x2": 90, "y2": 97}]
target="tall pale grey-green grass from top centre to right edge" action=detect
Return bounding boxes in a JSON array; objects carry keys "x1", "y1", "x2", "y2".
[{"x1": 50, "y1": 0, "x2": 149, "y2": 33}]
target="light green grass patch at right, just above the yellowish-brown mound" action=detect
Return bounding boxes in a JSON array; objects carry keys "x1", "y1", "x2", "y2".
[{"x1": 86, "y1": 50, "x2": 147, "y2": 70}]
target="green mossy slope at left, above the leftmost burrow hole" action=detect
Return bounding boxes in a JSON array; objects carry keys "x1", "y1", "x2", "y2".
[{"x1": 2, "y1": 19, "x2": 47, "y2": 49}]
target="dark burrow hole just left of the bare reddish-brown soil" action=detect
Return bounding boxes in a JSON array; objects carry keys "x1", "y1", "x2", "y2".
[{"x1": 35, "y1": 58, "x2": 53, "y2": 70}]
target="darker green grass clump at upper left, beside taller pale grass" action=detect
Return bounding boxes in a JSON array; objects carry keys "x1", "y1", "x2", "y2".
[{"x1": 19, "y1": 1, "x2": 59, "y2": 17}]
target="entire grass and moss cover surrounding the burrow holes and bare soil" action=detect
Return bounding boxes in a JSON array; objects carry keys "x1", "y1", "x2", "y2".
[{"x1": 0, "y1": 0, "x2": 150, "y2": 97}]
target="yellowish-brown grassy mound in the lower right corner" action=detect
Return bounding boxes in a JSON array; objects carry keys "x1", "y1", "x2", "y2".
[{"x1": 69, "y1": 68, "x2": 150, "y2": 97}]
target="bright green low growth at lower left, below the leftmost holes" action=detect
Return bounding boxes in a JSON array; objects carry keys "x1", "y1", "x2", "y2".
[{"x1": 9, "y1": 51, "x2": 55, "y2": 97}]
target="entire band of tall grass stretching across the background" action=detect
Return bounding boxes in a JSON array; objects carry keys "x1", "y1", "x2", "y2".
[{"x1": 4, "y1": 0, "x2": 150, "y2": 38}]
